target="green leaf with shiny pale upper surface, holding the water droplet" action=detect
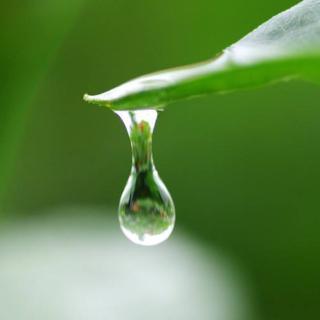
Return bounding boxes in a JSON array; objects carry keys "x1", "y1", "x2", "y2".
[{"x1": 84, "y1": 0, "x2": 320, "y2": 110}]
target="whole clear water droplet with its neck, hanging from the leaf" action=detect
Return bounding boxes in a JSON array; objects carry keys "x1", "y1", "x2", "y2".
[{"x1": 116, "y1": 109, "x2": 175, "y2": 246}]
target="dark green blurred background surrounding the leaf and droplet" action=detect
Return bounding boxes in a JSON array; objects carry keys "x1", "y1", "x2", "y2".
[{"x1": 0, "y1": 0, "x2": 320, "y2": 319}]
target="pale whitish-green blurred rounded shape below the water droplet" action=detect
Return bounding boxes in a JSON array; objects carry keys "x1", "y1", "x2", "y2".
[{"x1": 0, "y1": 206, "x2": 253, "y2": 320}]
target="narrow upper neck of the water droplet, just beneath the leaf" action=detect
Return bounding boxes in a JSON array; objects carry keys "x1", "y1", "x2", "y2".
[{"x1": 116, "y1": 109, "x2": 157, "y2": 173}]
